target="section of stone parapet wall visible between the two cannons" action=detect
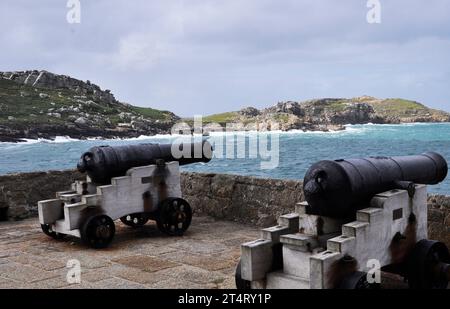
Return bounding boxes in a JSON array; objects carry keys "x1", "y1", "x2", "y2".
[{"x1": 181, "y1": 173, "x2": 303, "y2": 227}]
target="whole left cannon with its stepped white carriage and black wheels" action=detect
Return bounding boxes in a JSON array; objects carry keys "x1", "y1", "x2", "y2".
[{"x1": 38, "y1": 141, "x2": 212, "y2": 248}]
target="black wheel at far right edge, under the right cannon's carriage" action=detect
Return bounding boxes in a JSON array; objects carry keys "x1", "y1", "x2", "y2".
[{"x1": 406, "y1": 239, "x2": 450, "y2": 289}]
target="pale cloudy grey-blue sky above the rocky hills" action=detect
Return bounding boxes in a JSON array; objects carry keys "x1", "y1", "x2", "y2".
[{"x1": 0, "y1": 0, "x2": 450, "y2": 116}]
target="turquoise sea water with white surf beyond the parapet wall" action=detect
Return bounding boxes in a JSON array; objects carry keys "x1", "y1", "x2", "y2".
[{"x1": 0, "y1": 123, "x2": 450, "y2": 194}]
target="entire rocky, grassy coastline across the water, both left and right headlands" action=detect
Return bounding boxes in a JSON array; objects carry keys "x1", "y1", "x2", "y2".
[{"x1": 0, "y1": 70, "x2": 450, "y2": 142}]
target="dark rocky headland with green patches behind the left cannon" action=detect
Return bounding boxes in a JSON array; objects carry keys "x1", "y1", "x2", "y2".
[{"x1": 0, "y1": 70, "x2": 179, "y2": 142}]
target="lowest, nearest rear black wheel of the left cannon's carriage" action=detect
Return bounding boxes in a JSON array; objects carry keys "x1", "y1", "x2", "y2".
[{"x1": 80, "y1": 215, "x2": 116, "y2": 249}]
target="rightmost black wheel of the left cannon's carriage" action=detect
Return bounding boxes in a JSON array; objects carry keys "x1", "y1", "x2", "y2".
[{"x1": 156, "y1": 198, "x2": 192, "y2": 236}]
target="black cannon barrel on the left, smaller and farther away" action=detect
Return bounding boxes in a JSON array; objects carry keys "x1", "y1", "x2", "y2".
[{"x1": 77, "y1": 141, "x2": 213, "y2": 184}]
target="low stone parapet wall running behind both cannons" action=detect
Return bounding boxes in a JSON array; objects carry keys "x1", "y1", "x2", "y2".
[{"x1": 0, "y1": 170, "x2": 450, "y2": 246}]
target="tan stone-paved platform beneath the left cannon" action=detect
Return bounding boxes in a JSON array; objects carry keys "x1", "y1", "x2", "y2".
[{"x1": 0, "y1": 217, "x2": 259, "y2": 289}]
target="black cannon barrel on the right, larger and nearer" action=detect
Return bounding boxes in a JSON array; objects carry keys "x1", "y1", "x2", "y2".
[{"x1": 303, "y1": 152, "x2": 448, "y2": 218}]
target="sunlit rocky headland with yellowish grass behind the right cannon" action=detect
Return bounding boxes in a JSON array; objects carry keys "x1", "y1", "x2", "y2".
[{"x1": 207, "y1": 96, "x2": 450, "y2": 131}]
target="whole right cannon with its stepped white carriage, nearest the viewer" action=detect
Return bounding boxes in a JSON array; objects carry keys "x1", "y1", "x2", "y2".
[{"x1": 236, "y1": 152, "x2": 450, "y2": 289}]
